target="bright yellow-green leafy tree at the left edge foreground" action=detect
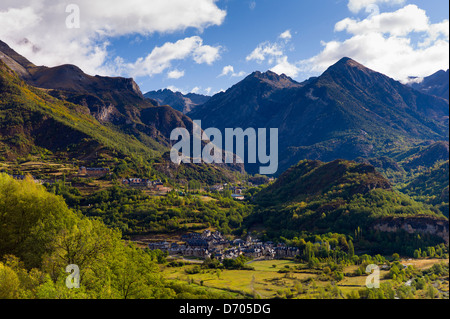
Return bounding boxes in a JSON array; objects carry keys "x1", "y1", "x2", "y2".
[{"x1": 0, "y1": 174, "x2": 77, "y2": 268}]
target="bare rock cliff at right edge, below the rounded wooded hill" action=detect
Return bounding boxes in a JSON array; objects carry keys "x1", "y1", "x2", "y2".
[{"x1": 373, "y1": 217, "x2": 449, "y2": 244}]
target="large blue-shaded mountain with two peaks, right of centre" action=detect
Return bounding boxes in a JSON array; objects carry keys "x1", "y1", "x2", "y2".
[{"x1": 188, "y1": 58, "x2": 449, "y2": 173}]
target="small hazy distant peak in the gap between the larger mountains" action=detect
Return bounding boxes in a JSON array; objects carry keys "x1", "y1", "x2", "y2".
[{"x1": 144, "y1": 89, "x2": 211, "y2": 114}]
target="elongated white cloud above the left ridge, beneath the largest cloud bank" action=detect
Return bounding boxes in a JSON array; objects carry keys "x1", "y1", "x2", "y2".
[{"x1": 118, "y1": 36, "x2": 220, "y2": 77}]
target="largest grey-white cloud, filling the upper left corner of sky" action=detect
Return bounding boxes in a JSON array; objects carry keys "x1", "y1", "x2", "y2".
[{"x1": 0, "y1": 0, "x2": 226, "y2": 74}]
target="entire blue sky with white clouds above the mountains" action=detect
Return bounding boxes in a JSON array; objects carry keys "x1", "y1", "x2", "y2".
[{"x1": 0, "y1": 0, "x2": 449, "y2": 95}]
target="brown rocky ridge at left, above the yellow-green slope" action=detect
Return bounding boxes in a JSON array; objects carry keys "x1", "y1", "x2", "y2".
[{"x1": 0, "y1": 41, "x2": 199, "y2": 148}]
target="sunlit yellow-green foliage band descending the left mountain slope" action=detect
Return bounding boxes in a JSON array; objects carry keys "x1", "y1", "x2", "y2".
[{"x1": 0, "y1": 63, "x2": 164, "y2": 157}]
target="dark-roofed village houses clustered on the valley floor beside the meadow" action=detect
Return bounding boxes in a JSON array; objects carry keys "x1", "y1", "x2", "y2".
[{"x1": 148, "y1": 230, "x2": 300, "y2": 261}]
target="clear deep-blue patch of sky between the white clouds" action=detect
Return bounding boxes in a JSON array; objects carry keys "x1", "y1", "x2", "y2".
[{"x1": 124, "y1": 0, "x2": 348, "y2": 93}]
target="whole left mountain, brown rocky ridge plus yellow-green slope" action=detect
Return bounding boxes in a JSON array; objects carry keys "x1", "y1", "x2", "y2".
[{"x1": 0, "y1": 41, "x2": 243, "y2": 182}]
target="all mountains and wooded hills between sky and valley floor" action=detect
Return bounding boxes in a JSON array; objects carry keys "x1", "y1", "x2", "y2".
[{"x1": 0, "y1": 41, "x2": 449, "y2": 249}]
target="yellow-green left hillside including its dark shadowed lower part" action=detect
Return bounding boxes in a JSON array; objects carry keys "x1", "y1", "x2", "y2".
[{"x1": 0, "y1": 61, "x2": 163, "y2": 162}]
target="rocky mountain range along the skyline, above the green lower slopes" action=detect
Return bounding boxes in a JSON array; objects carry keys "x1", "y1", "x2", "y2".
[{"x1": 0, "y1": 41, "x2": 449, "y2": 180}]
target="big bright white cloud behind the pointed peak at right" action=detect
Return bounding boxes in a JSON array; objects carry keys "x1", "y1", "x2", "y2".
[{"x1": 301, "y1": 5, "x2": 449, "y2": 82}]
